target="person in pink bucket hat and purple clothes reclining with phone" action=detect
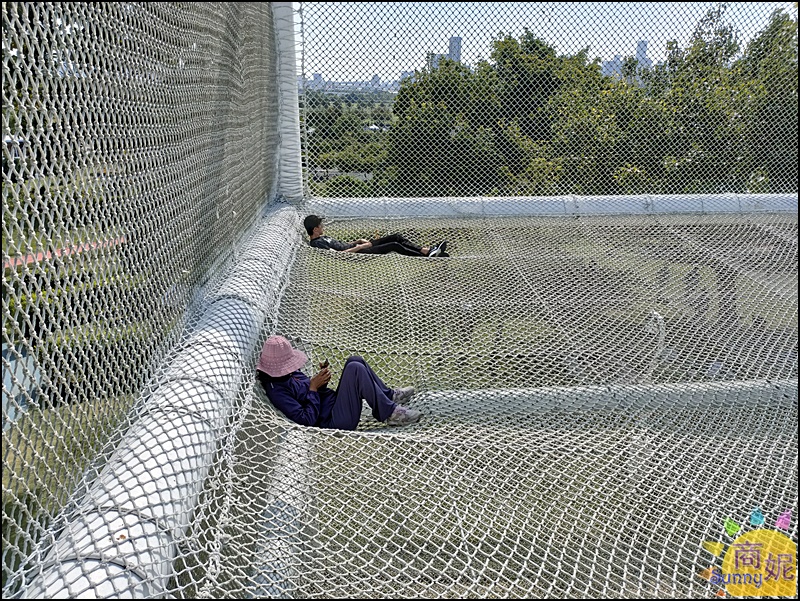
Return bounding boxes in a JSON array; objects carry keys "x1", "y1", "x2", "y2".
[{"x1": 257, "y1": 336, "x2": 422, "y2": 430}]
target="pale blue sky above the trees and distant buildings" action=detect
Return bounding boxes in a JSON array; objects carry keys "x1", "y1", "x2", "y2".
[{"x1": 294, "y1": 2, "x2": 797, "y2": 81}]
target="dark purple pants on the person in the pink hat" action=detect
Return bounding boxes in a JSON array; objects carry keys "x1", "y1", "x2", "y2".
[{"x1": 321, "y1": 356, "x2": 396, "y2": 430}]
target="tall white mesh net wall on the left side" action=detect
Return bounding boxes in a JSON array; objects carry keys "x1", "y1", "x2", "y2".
[{"x1": 2, "y1": 2, "x2": 277, "y2": 596}]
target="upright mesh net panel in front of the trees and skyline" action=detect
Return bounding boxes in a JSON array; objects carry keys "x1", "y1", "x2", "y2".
[{"x1": 300, "y1": 2, "x2": 797, "y2": 197}]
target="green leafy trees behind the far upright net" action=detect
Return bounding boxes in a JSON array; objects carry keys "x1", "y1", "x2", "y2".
[{"x1": 308, "y1": 5, "x2": 798, "y2": 196}]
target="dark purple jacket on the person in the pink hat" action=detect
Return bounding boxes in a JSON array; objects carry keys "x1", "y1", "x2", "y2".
[{"x1": 257, "y1": 370, "x2": 336, "y2": 426}]
